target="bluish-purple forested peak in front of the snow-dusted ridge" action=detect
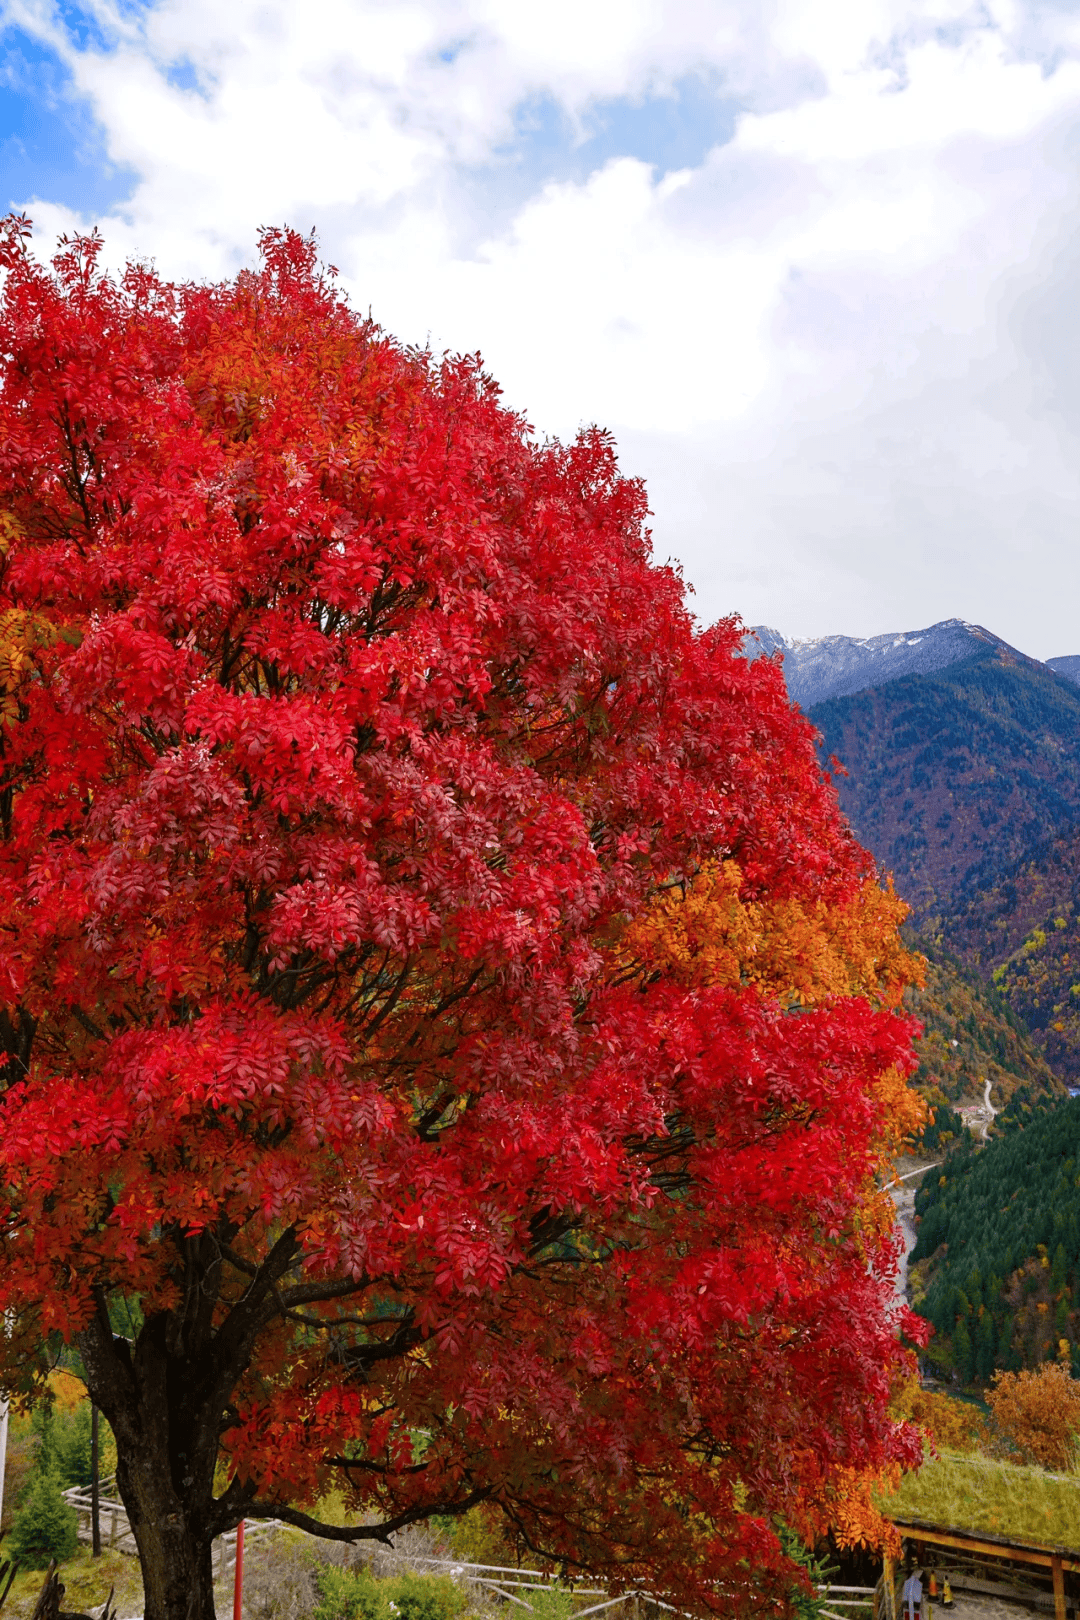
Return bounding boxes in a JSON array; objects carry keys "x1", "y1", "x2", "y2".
[{"x1": 810, "y1": 638, "x2": 1080, "y2": 926}]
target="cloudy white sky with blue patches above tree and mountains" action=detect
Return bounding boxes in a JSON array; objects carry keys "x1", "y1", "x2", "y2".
[{"x1": 0, "y1": 0, "x2": 1080, "y2": 658}]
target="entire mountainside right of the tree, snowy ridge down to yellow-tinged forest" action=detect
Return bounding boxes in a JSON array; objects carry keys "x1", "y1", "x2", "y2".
[{"x1": 743, "y1": 619, "x2": 1080, "y2": 1088}]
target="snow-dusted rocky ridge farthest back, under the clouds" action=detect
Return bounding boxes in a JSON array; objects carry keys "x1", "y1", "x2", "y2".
[{"x1": 743, "y1": 619, "x2": 1029, "y2": 710}]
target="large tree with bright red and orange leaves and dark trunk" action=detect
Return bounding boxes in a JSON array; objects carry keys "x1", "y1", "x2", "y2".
[{"x1": 0, "y1": 219, "x2": 912, "y2": 1620}]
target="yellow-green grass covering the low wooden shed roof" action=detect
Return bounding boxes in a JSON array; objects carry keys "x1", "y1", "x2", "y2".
[{"x1": 881, "y1": 1452, "x2": 1080, "y2": 1550}]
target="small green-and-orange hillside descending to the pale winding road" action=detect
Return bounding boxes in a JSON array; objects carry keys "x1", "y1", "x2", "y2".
[{"x1": 905, "y1": 940, "x2": 1065, "y2": 1114}]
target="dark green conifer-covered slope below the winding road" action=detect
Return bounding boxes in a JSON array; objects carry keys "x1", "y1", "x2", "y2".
[{"x1": 912, "y1": 1098, "x2": 1080, "y2": 1383}]
